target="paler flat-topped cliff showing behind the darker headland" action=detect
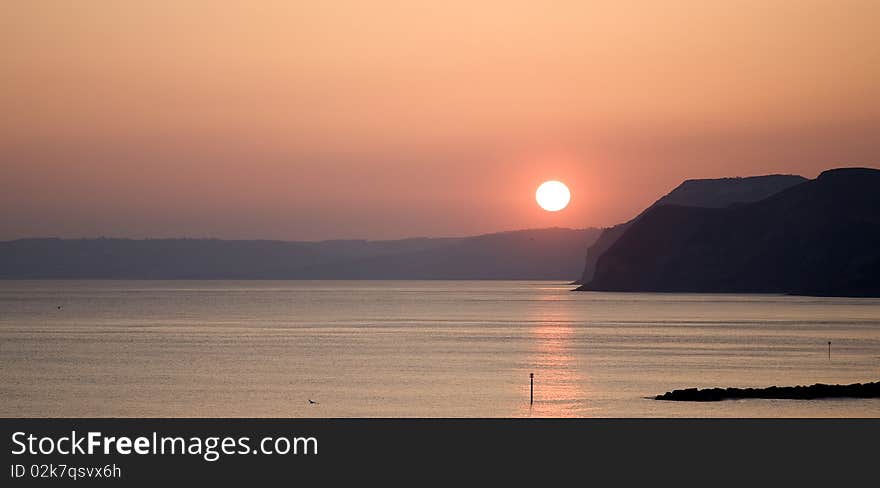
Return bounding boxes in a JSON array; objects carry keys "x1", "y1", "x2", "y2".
[{"x1": 579, "y1": 175, "x2": 807, "y2": 284}]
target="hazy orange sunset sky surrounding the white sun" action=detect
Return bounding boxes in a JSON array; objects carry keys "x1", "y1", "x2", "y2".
[{"x1": 0, "y1": 0, "x2": 880, "y2": 239}]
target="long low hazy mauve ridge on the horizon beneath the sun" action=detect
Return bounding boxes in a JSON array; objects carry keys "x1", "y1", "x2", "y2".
[{"x1": 0, "y1": 228, "x2": 600, "y2": 281}]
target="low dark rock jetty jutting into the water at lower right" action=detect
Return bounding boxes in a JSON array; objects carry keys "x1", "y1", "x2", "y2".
[{"x1": 654, "y1": 381, "x2": 880, "y2": 402}]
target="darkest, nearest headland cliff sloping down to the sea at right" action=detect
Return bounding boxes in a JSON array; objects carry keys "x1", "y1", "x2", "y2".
[{"x1": 582, "y1": 168, "x2": 880, "y2": 296}]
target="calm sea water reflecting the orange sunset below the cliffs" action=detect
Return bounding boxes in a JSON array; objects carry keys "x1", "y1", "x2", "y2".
[{"x1": 0, "y1": 281, "x2": 880, "y2": 417}]
